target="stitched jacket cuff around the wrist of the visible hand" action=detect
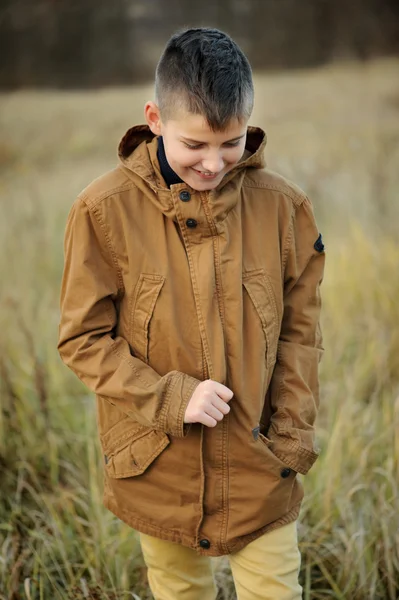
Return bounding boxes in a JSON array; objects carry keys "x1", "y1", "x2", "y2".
[{"x1": 157, "y1": 371, "x2": 201, "y2": 437}]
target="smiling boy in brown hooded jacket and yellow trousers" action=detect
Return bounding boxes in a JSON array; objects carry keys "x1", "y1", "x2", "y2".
[{"x1": 59, "y1": 29, "x2": 324, "y2": 600}]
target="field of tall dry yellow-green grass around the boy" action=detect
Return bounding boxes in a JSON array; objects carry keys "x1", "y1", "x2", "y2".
[{"x1": 0, "y1": 59, "x2": 399, "y2": 600}]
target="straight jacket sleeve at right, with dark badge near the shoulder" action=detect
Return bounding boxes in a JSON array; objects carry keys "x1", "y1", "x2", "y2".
[{"x1": 268, "y1": 198, "x2": 325, "y2": 474}]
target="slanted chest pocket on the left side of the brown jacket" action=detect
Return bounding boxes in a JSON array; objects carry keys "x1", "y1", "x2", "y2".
[{"x1": 129, "y1": 273, "x2": 165, "y2": 363}]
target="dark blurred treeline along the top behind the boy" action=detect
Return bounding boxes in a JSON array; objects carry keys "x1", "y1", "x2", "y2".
[{"x1": 0, "y1": 0, "x2": 399, "y2": 89}]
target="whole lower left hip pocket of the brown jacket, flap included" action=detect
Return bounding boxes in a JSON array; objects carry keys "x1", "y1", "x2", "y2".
[{"x1": 101, "y1": 419, "x2": 170, "y2": 479}]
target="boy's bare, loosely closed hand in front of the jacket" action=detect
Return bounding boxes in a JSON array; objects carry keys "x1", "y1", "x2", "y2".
[{"x1": 184, "y1": 379, "x2": 233, "y2": 427}]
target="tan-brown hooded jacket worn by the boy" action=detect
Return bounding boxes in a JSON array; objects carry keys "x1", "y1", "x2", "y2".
[{"x1": 58, "y1": 126, "x2": 324, "y2": 556}]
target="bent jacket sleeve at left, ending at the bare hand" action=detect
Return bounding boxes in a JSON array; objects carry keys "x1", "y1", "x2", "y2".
[{"x1": 58, "y1": 197, "x2": 200, "y2": 437}]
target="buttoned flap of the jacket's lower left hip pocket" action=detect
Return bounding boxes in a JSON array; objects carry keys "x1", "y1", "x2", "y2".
[{"x1": 104, "y1": 429, "x2": 170, "y2": 479}]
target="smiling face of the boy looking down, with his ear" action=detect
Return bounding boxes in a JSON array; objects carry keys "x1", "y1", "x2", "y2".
[{"x1": 145, "y1": 102, "x2": 247, "y2": 191}]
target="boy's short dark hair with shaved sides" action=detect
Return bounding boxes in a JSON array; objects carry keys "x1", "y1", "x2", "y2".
[{"x1": 155, "y1": 28, "x2": 254, "y2": 131}]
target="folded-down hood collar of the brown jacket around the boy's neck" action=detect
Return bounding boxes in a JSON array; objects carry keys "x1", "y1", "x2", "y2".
[{"x1": 118, "y1": 125, "x2": 267, "y2": 219}]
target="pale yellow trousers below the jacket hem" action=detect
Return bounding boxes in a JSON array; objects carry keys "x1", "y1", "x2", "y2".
[{"x1": 140, "y1": 522, "x2": 302, "y2": 600}]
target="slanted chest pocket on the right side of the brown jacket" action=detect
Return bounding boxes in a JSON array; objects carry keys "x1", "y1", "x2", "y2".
[{"x1": 242, "y1": 269, "x2": 280, "y2": 368}]
